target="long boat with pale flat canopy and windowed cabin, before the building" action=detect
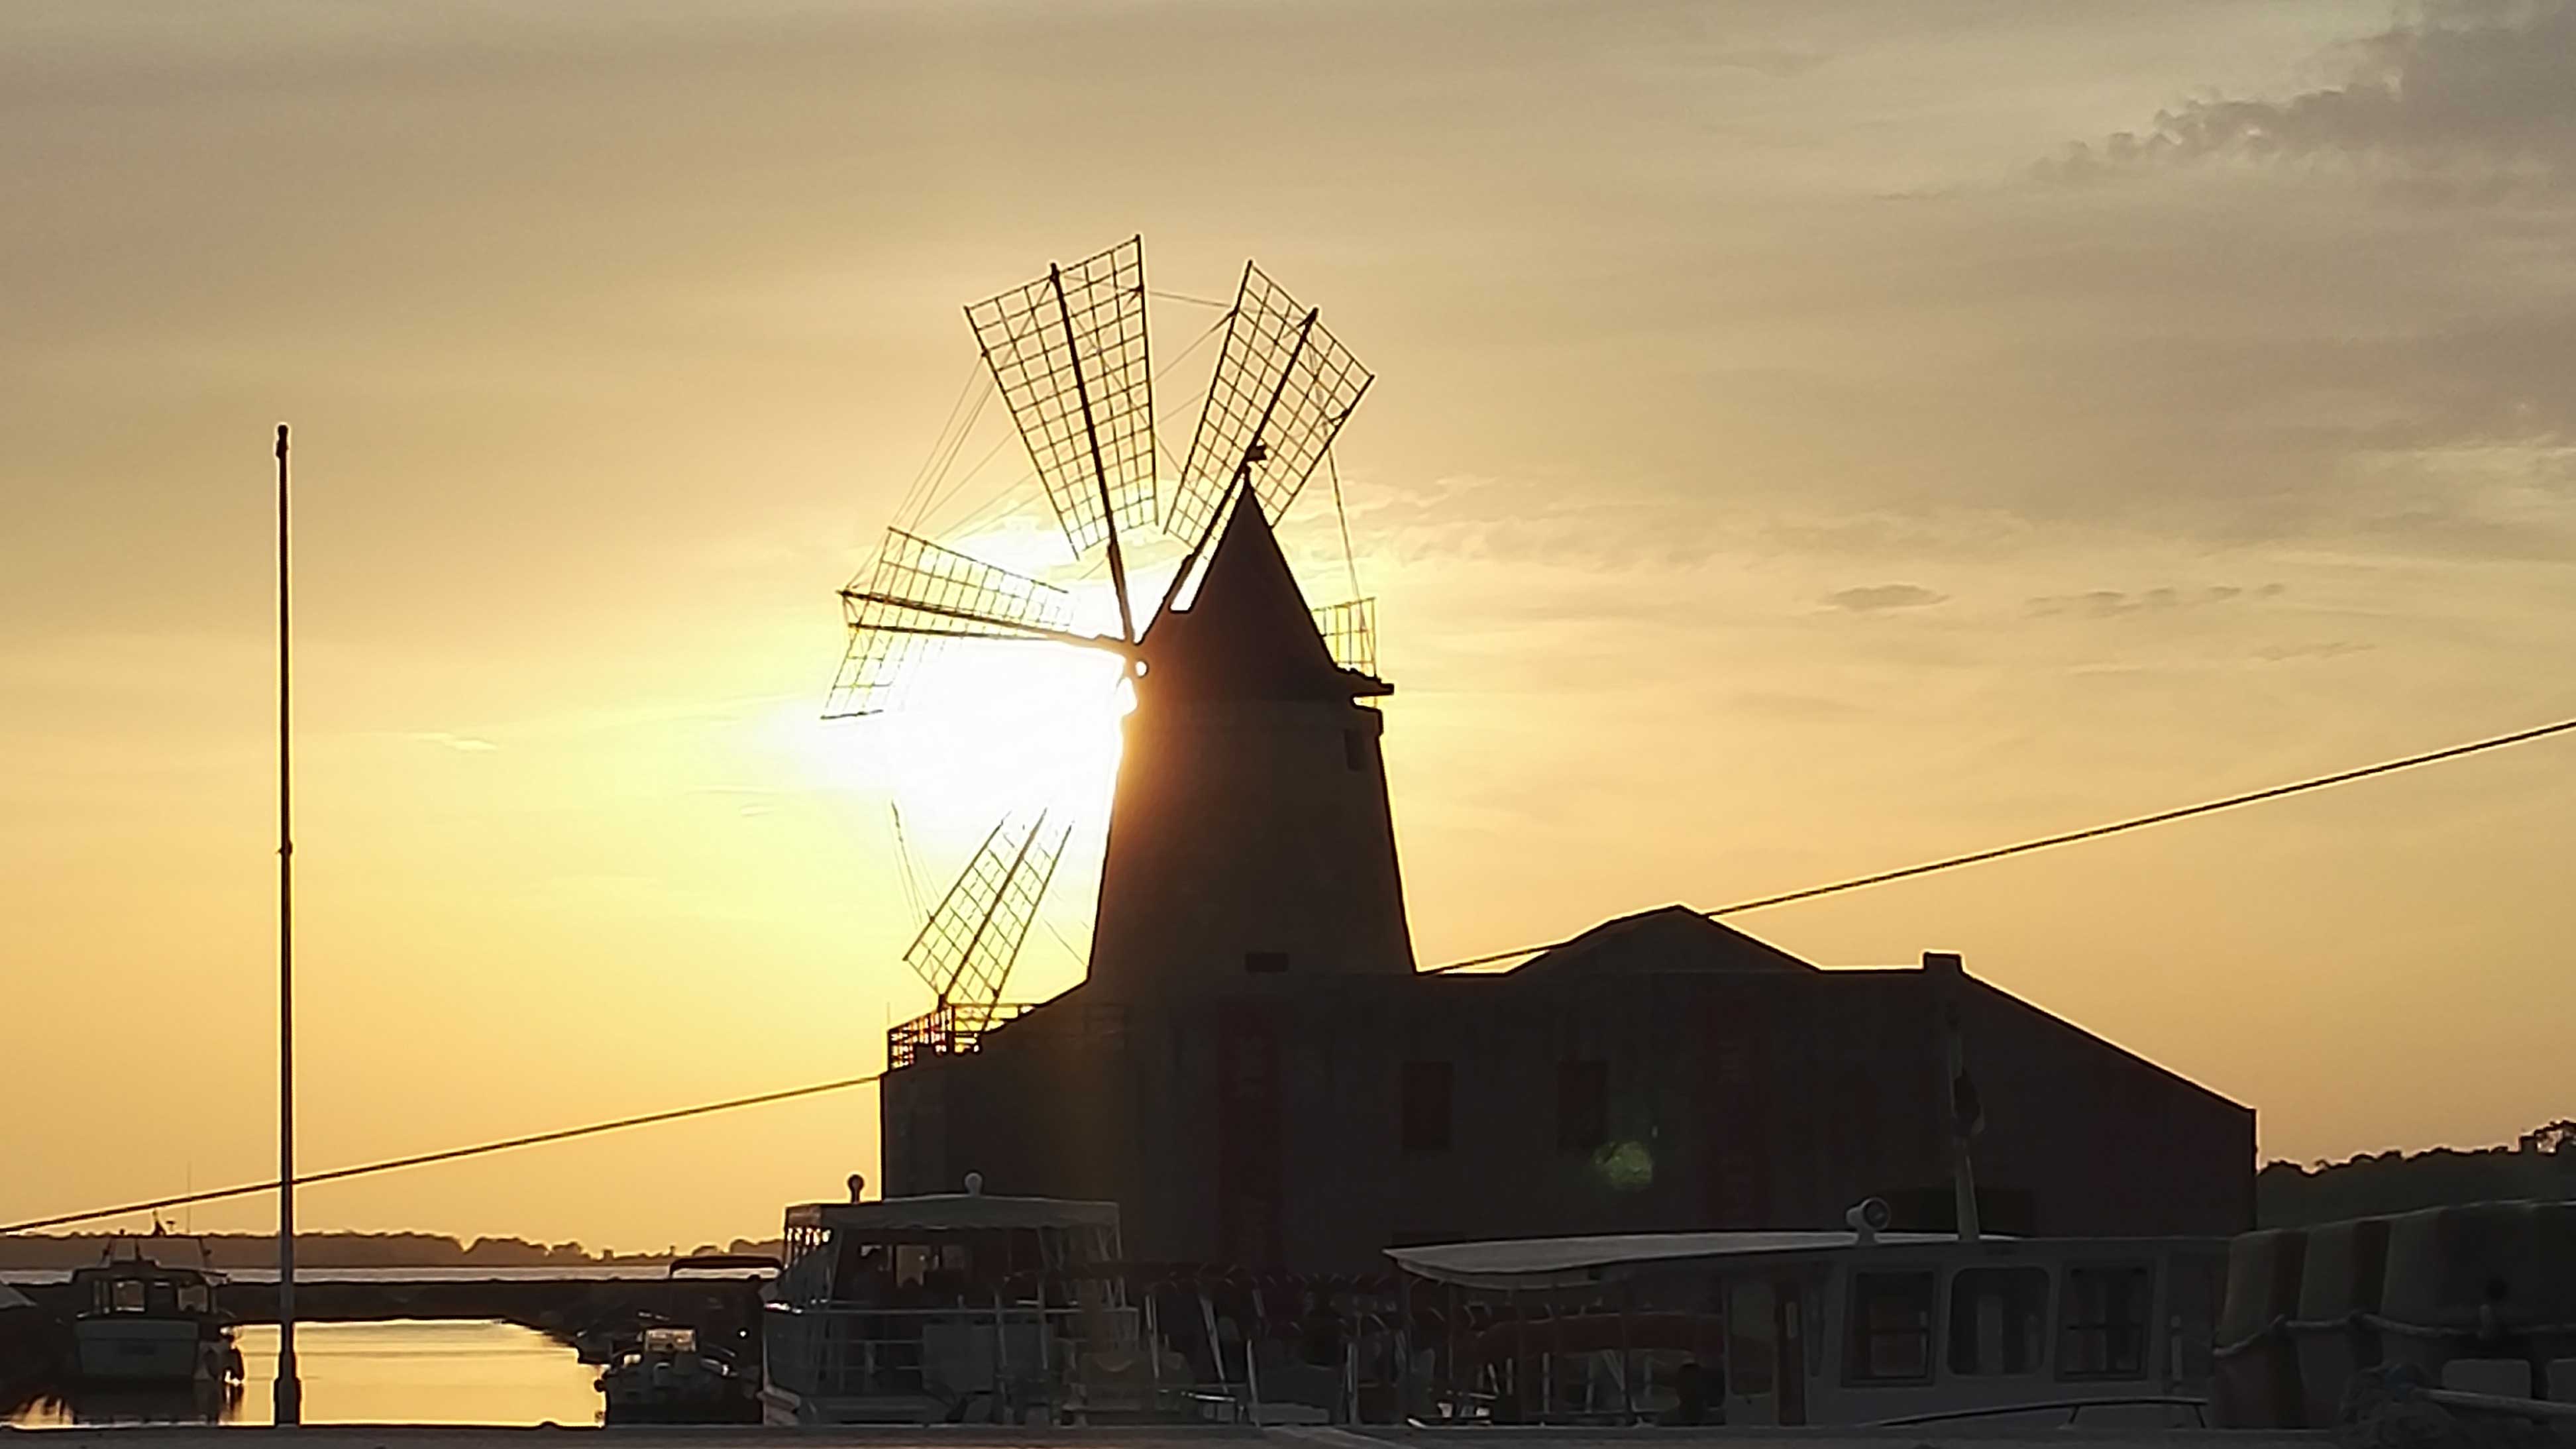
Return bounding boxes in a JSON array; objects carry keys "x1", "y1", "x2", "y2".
[{"x1": 1389, "y1": 1199, "x2": 2228, "y2": 1428}]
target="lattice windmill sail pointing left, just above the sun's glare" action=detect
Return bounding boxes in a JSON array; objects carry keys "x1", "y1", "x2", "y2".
[{"x1": 822, "y1": 529, "x2": 1074, "y2": 720}]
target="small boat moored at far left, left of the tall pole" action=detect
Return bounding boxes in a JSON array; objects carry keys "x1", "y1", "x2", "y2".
[{"x1": 70, "y1": 1232, "x2": 242, "y2": 1385}]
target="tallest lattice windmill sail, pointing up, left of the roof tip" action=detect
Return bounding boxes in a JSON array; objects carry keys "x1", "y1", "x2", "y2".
[{"x1": 966, "y1": 237, "x2": 1159, "y2": 557}]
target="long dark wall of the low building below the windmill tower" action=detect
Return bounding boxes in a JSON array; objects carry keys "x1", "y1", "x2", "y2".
[{"x1": 884, "y1": 969, "x2": 2254, "y2": 1271}]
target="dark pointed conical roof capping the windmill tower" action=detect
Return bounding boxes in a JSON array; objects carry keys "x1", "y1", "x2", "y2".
[{"x1": 1144, "y1": 490, "x2": 1378, "y2": 699}]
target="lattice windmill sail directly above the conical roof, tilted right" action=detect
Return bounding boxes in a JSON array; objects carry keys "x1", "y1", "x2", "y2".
[{"x1": 1161, "y1": 263, "x2": 1370, "y2": 544}]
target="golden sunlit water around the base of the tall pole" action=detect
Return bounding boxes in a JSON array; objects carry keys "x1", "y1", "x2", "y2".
[{"x1": 8, "y1": 1320, "x2": 600, "y2": 1428}]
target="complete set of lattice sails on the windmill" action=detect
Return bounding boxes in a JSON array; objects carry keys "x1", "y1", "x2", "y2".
[{"x1": 824, "y1": 237, "x2": 1383, "y2": 1052}]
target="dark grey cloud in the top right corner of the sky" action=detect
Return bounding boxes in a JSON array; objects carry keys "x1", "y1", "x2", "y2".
[{"x1": 2040, "y1": 0, "x2": 2576, "y2": 199}]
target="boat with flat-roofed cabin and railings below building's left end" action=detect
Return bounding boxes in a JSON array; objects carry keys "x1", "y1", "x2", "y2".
[{"x1": 760, "y1": 1173, "x2": 1138, "y2": 1426}]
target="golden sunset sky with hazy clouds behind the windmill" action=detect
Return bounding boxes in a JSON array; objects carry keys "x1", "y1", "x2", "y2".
[{"x1": 0, "y1": 0, "x2": 2576, "y2": 1248}]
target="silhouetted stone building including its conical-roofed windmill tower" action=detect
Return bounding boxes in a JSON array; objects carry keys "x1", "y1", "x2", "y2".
[{"x1": 881, "y1": 495, "x2": 2254, "y2": 1273}]
